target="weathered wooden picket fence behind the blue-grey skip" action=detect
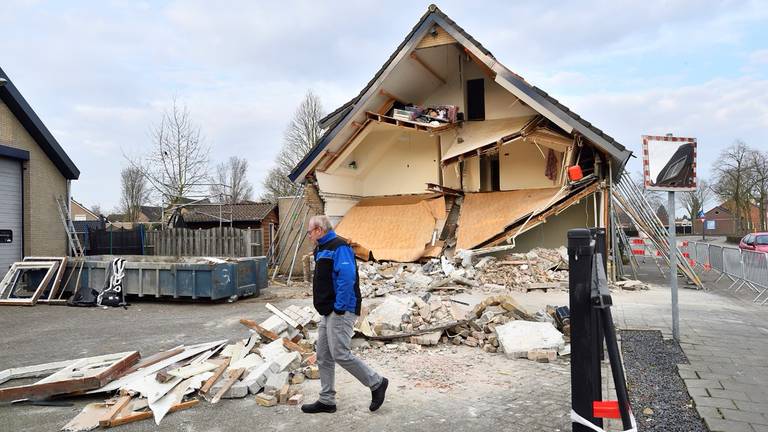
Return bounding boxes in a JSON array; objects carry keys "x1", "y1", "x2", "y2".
[{"x1": 144, "y1": 227, "x2": 265, "y2": 257}]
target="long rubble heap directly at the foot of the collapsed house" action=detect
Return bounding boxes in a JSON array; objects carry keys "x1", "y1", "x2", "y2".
[{"x1": 358, "y1": 247, "x2": 568, "y2": 298}]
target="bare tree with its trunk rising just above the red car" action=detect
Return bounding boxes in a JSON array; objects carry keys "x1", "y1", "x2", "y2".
[{"x1": 712, "y1": 140, "x2": 752, "y2": 235}]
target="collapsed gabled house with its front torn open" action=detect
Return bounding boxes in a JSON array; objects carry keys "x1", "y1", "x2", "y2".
[{"x1": 283, "y1": 5, "x2": 631, "y2": 262}]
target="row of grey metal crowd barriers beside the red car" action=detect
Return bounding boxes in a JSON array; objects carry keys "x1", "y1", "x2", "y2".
[{"x1": 688, "y1": 242, "x2": 768, "y2": 305}]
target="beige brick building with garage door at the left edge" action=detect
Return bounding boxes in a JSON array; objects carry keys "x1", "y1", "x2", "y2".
[{"x1": 0, "y1": 69, "x2": 80, "y2": 274}]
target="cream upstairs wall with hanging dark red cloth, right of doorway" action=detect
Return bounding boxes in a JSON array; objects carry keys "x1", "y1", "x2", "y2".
[{"x1": 499, "y1": 140, "x2": 562, "y2": 190}]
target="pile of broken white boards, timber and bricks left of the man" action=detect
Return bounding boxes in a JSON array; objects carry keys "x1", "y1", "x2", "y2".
[{"x1": 0, "y1": 303, "x2": 320, "y2": 431}]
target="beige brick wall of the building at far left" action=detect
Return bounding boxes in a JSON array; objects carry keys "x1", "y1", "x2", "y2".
[{"x1": 0, "y1": 102, "x2": 67, "y2": 256}]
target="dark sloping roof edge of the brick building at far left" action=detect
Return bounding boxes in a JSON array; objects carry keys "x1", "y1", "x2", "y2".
[{"x1": 0, "y1": 68, "x2": 80, "y2": 180}]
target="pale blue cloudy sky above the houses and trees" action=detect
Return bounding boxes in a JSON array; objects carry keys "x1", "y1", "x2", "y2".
[{"x1": 0, "y1": 0, "x2": 768, "y2": 210}]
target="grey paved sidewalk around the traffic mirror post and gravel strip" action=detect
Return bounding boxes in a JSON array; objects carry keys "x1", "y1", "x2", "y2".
[{"x1": 613, "y1": 266, "x2": 768, "y2": 432}]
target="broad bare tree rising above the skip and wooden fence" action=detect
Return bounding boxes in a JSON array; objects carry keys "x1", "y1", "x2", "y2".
[{"x1": 129, "y1": 99, "x2": 209, "y2": 204}]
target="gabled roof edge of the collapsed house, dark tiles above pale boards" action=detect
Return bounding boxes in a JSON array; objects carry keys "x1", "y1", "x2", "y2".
[{"x1": 289, "y1": 4, "x2": 632, "y2": 181}]
